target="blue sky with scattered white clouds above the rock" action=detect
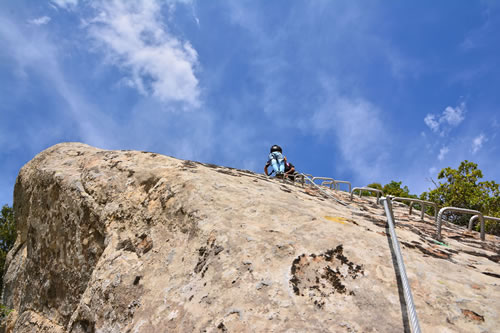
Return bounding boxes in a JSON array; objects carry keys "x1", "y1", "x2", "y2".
[{"x1": 0, "y1": 0, "x2": 500, "y2": 204}]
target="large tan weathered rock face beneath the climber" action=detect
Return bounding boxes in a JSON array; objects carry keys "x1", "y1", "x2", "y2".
[{"x1": 3, "y1": 143, "x2": 500, "y2": 332}]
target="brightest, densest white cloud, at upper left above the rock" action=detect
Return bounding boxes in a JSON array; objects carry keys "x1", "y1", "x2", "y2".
[{"x1": 87, "y1": 0, "x2": 200, "y2": 107}]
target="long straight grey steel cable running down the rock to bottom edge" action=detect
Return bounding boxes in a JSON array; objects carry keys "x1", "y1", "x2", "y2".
[{"x1": 380, "y1": 197, "x2": 421, "y2": 333}]
